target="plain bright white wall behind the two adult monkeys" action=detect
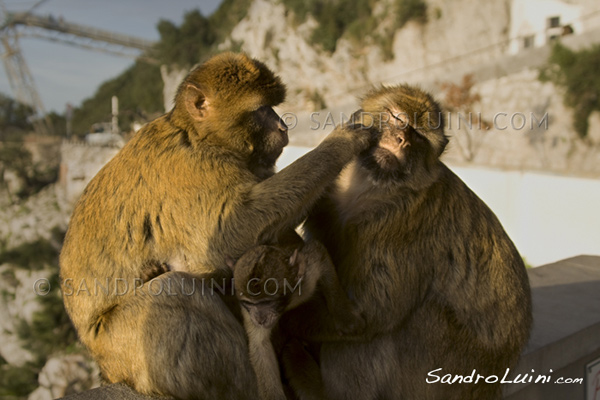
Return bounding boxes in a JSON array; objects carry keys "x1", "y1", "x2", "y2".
[{"x1": 278, "y1": 147, "x2": 600, "y2": 266}]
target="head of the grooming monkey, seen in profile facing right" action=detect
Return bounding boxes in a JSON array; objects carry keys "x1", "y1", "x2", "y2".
[{"x1": 170, "y1": 52, "x2": 288, "y2": 173}]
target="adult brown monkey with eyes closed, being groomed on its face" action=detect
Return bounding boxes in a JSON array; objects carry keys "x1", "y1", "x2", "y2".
[{"x1": 282, "y1": 86, "x2": 531, "y2": 400}]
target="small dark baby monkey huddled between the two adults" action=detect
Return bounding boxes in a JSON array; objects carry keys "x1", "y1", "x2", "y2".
[{"x1": 227, "y1": 237, "x2": 364, "y2": 400}]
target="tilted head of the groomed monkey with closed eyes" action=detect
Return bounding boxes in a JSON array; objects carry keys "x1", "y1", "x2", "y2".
[{"x1": 356, "y1": 85, "x2": 448, "y2": 186}]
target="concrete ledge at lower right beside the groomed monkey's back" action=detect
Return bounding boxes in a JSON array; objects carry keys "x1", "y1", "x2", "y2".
[{"x1": 504, "y1": 256, "x2": 600, "y2": 400}]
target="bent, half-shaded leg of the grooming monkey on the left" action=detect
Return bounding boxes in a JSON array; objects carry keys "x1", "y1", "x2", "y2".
[{"x1": 90, "y1": 272, "x2": 258, "y2": 399}]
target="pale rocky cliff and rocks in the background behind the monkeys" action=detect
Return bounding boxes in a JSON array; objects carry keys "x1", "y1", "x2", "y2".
[{"x1": 0, "y1": 0, "x2": 600, "y2": 400}]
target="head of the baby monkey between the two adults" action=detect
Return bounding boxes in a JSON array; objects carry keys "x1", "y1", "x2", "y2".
[{"x1": 227, "y1": 245, "x2": 304, "y2": 329}]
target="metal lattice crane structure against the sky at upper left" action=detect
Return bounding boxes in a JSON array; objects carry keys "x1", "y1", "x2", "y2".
[{"x1": 0, "y1": 0, "x2": 156, "y2": 134}]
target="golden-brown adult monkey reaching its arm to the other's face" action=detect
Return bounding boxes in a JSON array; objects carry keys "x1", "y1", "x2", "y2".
[{"x1": 60, "y1": 53, "x2": 370, "y2": 399}]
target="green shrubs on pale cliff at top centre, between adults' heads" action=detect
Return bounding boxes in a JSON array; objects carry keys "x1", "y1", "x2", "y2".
[{"x1": 282, "y1": 0, "x2": 427, "y2": 58}]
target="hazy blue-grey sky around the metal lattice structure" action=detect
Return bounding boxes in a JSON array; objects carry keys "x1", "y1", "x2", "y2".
[{"x1": 0, "y1": 0, "x2": 221, "y2": 113}]
